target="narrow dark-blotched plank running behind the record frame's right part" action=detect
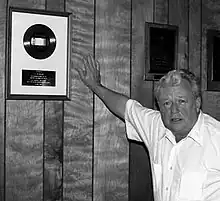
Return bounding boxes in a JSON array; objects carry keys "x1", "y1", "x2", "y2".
[{"x1": 44, "y1": 0, "x2": 65, "y2": 201}]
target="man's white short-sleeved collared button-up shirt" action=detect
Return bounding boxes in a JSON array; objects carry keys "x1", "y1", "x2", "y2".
[{"x1": 125, "y1": 99, "x2": 220, "y2": 201}]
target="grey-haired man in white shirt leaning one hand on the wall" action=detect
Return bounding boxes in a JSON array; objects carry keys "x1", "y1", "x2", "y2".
[{"x1": 75, "y1": 56, "x2": 220, "y2": 201}]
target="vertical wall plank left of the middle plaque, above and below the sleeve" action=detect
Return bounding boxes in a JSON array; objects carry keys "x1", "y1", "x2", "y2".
[{"x1": 129, "y1": 0, "x2": 155, "y2": 201}]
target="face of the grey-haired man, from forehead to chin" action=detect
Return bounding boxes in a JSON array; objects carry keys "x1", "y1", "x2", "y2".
[{"x1": 158, "y1": 79, "x2": 201, "y2": 137}]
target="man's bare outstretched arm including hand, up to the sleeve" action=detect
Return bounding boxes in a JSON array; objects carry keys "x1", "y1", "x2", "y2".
[{"x1": 76, "y1": 55, "x2": 129, "y2": 119}]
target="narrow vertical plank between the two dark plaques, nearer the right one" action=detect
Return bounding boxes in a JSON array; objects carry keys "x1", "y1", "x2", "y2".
[{"x1": 189, "y1": 0, "x2": 202, "y2": 77}]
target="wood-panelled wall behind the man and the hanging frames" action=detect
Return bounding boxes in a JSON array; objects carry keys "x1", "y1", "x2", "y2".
[{"x1": 0, "y1": 0, "x2": 220, "y2": 201}]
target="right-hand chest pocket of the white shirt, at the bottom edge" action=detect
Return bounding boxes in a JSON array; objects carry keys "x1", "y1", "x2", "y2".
[{"x1": 179, "y1": 171, "x2": 206, "y2": 201}]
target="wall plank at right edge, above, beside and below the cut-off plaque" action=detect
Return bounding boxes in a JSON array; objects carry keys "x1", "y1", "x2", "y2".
[{"x1": 201, "y1": 0, "x2": 220, "y2": 119}]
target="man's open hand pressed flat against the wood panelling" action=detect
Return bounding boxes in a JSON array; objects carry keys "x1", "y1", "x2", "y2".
[{"x1": 76, "y1": 55, "x2": 101, "y2": 90}]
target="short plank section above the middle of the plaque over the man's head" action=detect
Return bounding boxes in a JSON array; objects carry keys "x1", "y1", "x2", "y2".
[{"x1": 154, "y1": 0, "x2": 169, "y2": 24}]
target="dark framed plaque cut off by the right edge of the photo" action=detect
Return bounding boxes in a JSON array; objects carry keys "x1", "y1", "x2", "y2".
[{"x1": 207, "y1": 29, "x2": 220, "y2": 91}]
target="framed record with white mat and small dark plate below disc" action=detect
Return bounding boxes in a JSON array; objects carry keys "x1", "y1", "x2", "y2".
[{"x1": 6, "y1": 7, "x2": 71, "y2": 100}]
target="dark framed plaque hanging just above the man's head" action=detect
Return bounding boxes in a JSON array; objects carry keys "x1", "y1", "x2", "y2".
[{"x1": 144, "y1": 22, "x2": 178, "y2": 80}]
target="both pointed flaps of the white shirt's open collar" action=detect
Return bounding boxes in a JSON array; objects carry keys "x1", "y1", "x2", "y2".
[{"x1": 159, "y1": 110, "x2": 204, "y2": 146}]
